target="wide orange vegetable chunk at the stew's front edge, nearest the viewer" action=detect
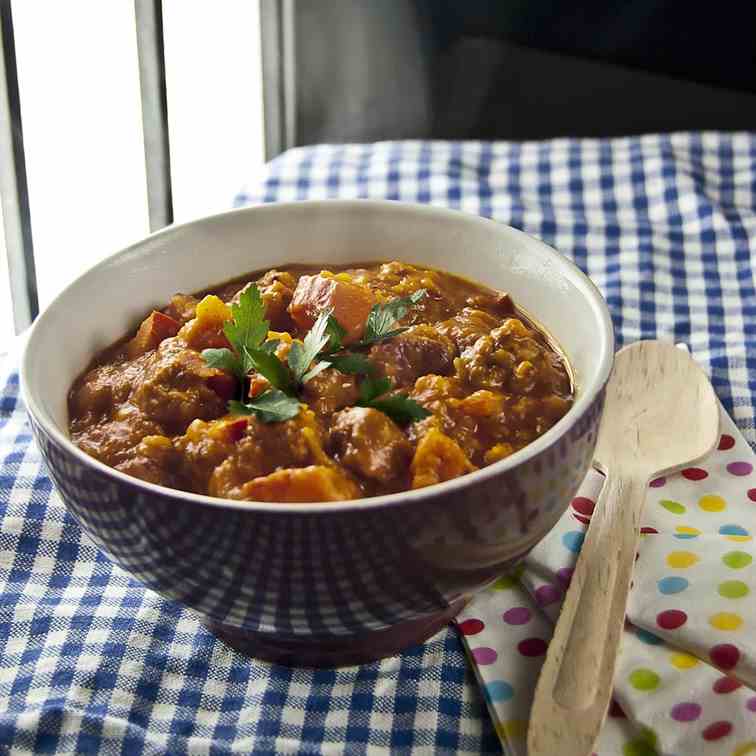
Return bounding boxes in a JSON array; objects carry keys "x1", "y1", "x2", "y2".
[{"x1": 242, "y1": 465, "x2": 360, "y2": 502}]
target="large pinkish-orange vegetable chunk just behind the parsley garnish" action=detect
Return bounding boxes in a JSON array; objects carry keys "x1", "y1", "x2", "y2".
[{"x1": 289, "y1": 276, "x2": 376, "y2": 344}]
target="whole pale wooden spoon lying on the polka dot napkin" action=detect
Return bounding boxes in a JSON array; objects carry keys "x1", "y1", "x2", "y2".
[{"x1": 528, "y1": 341, "x2": 719, "y2": 756}]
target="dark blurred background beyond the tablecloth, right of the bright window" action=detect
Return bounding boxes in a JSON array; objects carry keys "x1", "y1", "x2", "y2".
[{"x1": 262, "y1": 0, "x2": 756, "y2": 156}]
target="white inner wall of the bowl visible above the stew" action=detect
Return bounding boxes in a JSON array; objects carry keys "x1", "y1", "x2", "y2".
[{"x1": 22, "y1": 201, "x2": 613, "y2": 484}]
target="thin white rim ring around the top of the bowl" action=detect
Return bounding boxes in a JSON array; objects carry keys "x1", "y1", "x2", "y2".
[{"x1": 19, "y1": 199, "x2": 614, "y2": 515}]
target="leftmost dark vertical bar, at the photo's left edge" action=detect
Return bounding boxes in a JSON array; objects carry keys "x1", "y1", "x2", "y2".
[{"x1": 0, "y1": 0, "x2": 39, "y2": 333}]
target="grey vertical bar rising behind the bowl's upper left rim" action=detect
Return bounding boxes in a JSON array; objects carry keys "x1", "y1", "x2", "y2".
[{"x1": 134, "y1": 0, "x2": 173, "y2": 231}]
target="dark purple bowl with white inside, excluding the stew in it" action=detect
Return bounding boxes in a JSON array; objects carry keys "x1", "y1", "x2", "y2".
[{"x1": 21, "y1": 200, "x2": 614, "y2": 666}]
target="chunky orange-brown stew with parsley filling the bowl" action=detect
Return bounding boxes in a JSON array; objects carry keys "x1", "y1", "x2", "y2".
[{"x1": 68, "y1": 262, "x2": 573, "y2": 502}]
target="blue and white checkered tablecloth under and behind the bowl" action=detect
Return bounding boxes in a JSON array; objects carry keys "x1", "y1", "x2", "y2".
[{"x1": 0, "y1": 133, "x2": 756, "y2": 754}]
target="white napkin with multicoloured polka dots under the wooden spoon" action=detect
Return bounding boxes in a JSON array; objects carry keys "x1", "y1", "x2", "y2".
[{"x1": 457, "y1": 376, "x2": 756, "y2": 756}]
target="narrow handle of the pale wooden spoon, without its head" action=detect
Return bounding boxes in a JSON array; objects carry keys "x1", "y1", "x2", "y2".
[{"x1": 528, "y1": 475, "x2": 645, "y2": 756}]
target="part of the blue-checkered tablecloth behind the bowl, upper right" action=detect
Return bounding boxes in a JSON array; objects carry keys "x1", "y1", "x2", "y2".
[{"x1": 235, "y1": 132, "x2": 756, "y2": 445}]
